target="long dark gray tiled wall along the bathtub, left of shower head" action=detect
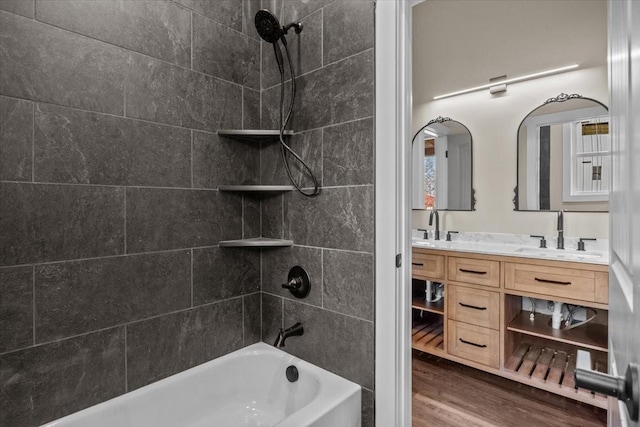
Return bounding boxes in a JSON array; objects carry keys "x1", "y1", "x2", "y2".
[{"x1": 0, "y1": 0, "x2": 261, "y2": 427}]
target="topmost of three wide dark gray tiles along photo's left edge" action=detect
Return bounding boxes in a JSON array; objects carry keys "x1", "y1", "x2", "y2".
[{"x1": 0, "y1": 12, "x2": 128, "y2": 115}]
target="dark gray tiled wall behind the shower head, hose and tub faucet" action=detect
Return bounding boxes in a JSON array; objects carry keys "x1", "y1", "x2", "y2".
[{"x1": 255, "y1": 0, "x2": 375, "y2": 426}]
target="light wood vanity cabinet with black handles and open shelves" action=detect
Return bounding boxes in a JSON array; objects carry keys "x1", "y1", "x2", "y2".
[{"x1": 412, "y1": 248, "x2": 608, "y2": 408}]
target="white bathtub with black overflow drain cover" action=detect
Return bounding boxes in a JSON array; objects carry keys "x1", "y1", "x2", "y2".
[{"x1": 45, "y1": 343, "x2": 361, "y2": 427}]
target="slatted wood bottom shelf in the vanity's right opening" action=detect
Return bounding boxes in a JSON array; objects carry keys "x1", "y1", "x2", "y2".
[{"x1": 504, "y1": 342, "x2": 607, "y2": 409}]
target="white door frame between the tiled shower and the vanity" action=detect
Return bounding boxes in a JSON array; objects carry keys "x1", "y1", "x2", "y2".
[{"x1": 375, "y1": 0, "x2": 411, "y2": 427}]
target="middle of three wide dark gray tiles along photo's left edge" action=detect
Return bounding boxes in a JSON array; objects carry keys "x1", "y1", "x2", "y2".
[{"x1": 0, "y1": 182, "x2": 124, "y2": 265}]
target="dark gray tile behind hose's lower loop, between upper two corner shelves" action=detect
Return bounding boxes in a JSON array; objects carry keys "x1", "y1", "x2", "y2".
[{"x1": 260, "y1": 129, "x2": 322, "y2": 188}]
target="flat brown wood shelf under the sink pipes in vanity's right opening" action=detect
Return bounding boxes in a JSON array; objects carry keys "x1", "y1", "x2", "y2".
[{"x1": 507, "y1": 311, "x2": 608, "y2": 352}]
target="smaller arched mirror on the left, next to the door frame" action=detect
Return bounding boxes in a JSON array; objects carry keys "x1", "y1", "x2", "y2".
[{"x1": 411, "y1": 117, "x2": 475, "y2": 211}]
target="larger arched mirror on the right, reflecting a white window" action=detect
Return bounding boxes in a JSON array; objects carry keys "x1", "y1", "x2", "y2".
[{"x1": 514, "y1": 93, "x2": 611, "y2": 212}]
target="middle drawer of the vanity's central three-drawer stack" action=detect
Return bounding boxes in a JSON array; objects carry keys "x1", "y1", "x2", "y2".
[{"x1": 447, "y1": 285, "x2": 500, "y2": 329}]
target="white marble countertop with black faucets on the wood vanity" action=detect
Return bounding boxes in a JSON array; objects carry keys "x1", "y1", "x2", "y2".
[{"x1": 411, "y1": 230, "x2": 609, "y2": 265}]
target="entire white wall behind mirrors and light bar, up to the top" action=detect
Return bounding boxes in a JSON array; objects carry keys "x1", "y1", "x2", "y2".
[{"x1": 412, "y1": 0, "x2": 609, "y2": 238}]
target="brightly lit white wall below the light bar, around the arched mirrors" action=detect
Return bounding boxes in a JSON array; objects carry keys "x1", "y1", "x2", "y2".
[{"x1": 412, "y1": 66, "x2": 609, "y2": 238}]
